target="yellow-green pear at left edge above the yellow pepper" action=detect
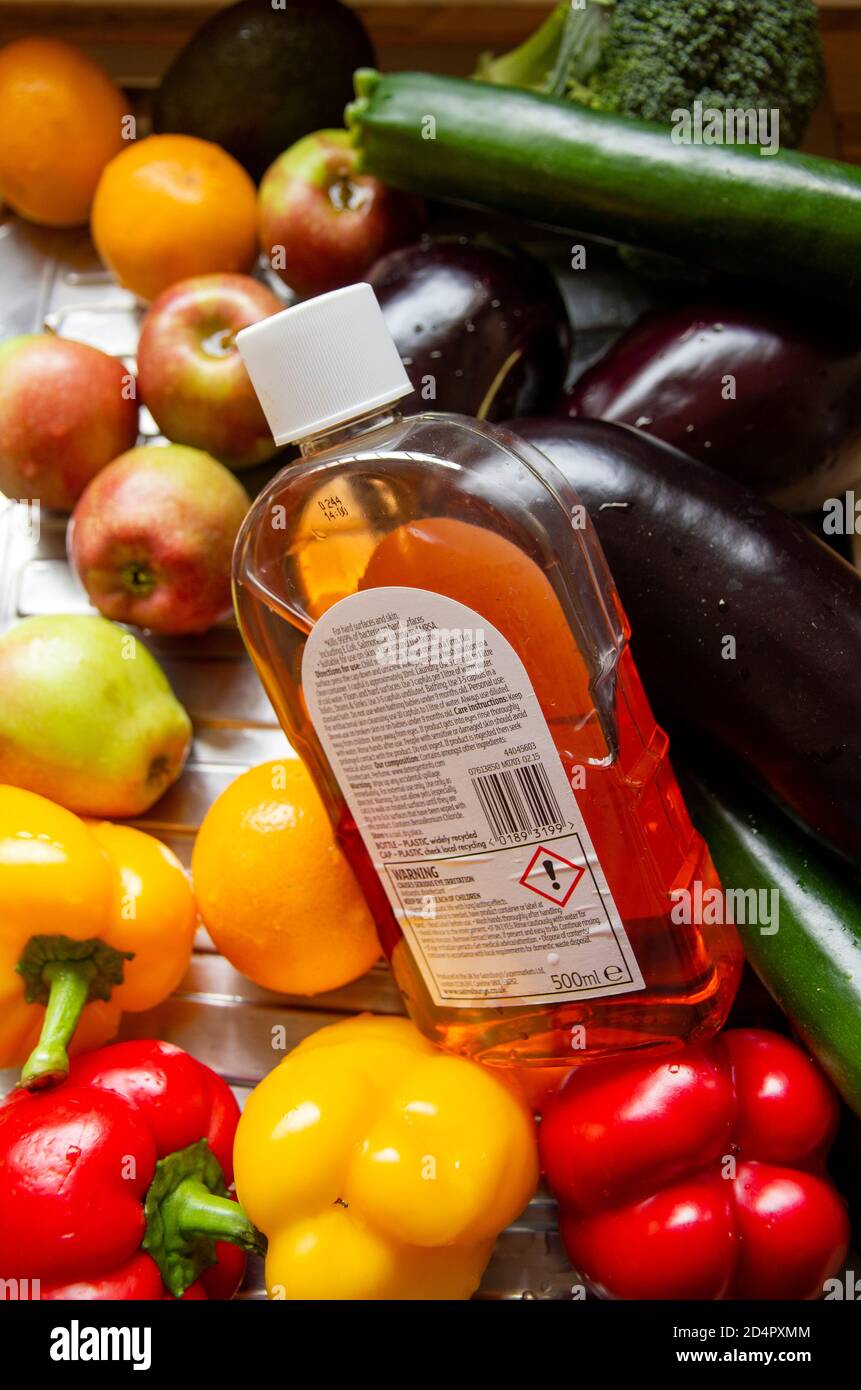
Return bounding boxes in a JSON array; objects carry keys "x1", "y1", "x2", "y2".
[{"x1": 0, "y1": 614, "x2": 192, "y2": 817}]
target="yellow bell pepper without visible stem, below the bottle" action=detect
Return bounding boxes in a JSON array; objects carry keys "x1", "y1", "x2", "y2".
[{"x1": 234, "y1": 1015, "x2": 538, "y2": 1300}]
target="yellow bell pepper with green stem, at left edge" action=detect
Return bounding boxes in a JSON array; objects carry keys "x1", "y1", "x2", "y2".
[{"x1": 0, "y1": 785, "x2": 196, "y2": 1088}]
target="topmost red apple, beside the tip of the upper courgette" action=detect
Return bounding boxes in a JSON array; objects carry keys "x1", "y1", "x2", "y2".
[{"x1": 257, "y1": 131, "x2": 424, "y2": 295}]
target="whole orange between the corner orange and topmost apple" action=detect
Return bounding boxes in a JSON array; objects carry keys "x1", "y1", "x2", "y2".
[{"x1": 90, "y1": 135, "x2": 257, "y2": 299}]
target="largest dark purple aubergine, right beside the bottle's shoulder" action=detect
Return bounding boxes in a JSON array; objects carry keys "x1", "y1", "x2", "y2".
[{"x1": 509, "y1": 420, "x2": 861, "y2": 863}]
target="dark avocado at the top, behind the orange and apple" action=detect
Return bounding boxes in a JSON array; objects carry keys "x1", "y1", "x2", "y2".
[{"x1": 153, "y1": 0, "x2": 374, "y2": 179}]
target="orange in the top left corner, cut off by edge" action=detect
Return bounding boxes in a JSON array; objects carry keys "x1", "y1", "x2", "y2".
[{"x1": 0, "y1": 39, "x2": 129, "y2": 227}]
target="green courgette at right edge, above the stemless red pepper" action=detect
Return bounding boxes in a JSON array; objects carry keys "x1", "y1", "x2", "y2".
[{"x1": 683, "y1": 776, "x2": 861, "y2": 1115}]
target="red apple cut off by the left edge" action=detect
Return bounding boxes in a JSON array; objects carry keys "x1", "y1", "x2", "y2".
[{"x1": 0, "y1": 334, "x2": 138, "y2": 512}]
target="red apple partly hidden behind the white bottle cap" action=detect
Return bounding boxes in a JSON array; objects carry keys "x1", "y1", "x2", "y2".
[{"x1": 138, "y1": 274, "x2": 284, "y2": 468}]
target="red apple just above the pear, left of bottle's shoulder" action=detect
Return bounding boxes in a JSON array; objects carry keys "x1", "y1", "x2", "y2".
[{"x1": 68, "y1": 445, "x2": 249, "y2": 632}]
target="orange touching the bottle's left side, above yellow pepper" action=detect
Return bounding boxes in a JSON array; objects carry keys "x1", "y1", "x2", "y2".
[{"x1": 192, "y1": 759, "x2": 380, "y2": 994}]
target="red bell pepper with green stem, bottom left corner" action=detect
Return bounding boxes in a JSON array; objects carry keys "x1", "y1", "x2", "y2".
[{"x1": 0, "y1": 1041, "x2": 263, "y2": 1298}]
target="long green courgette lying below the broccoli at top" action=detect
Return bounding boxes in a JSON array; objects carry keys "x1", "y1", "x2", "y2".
[{"x1": 346, "y1": 68, "x2": 861, "y2": 297}]
